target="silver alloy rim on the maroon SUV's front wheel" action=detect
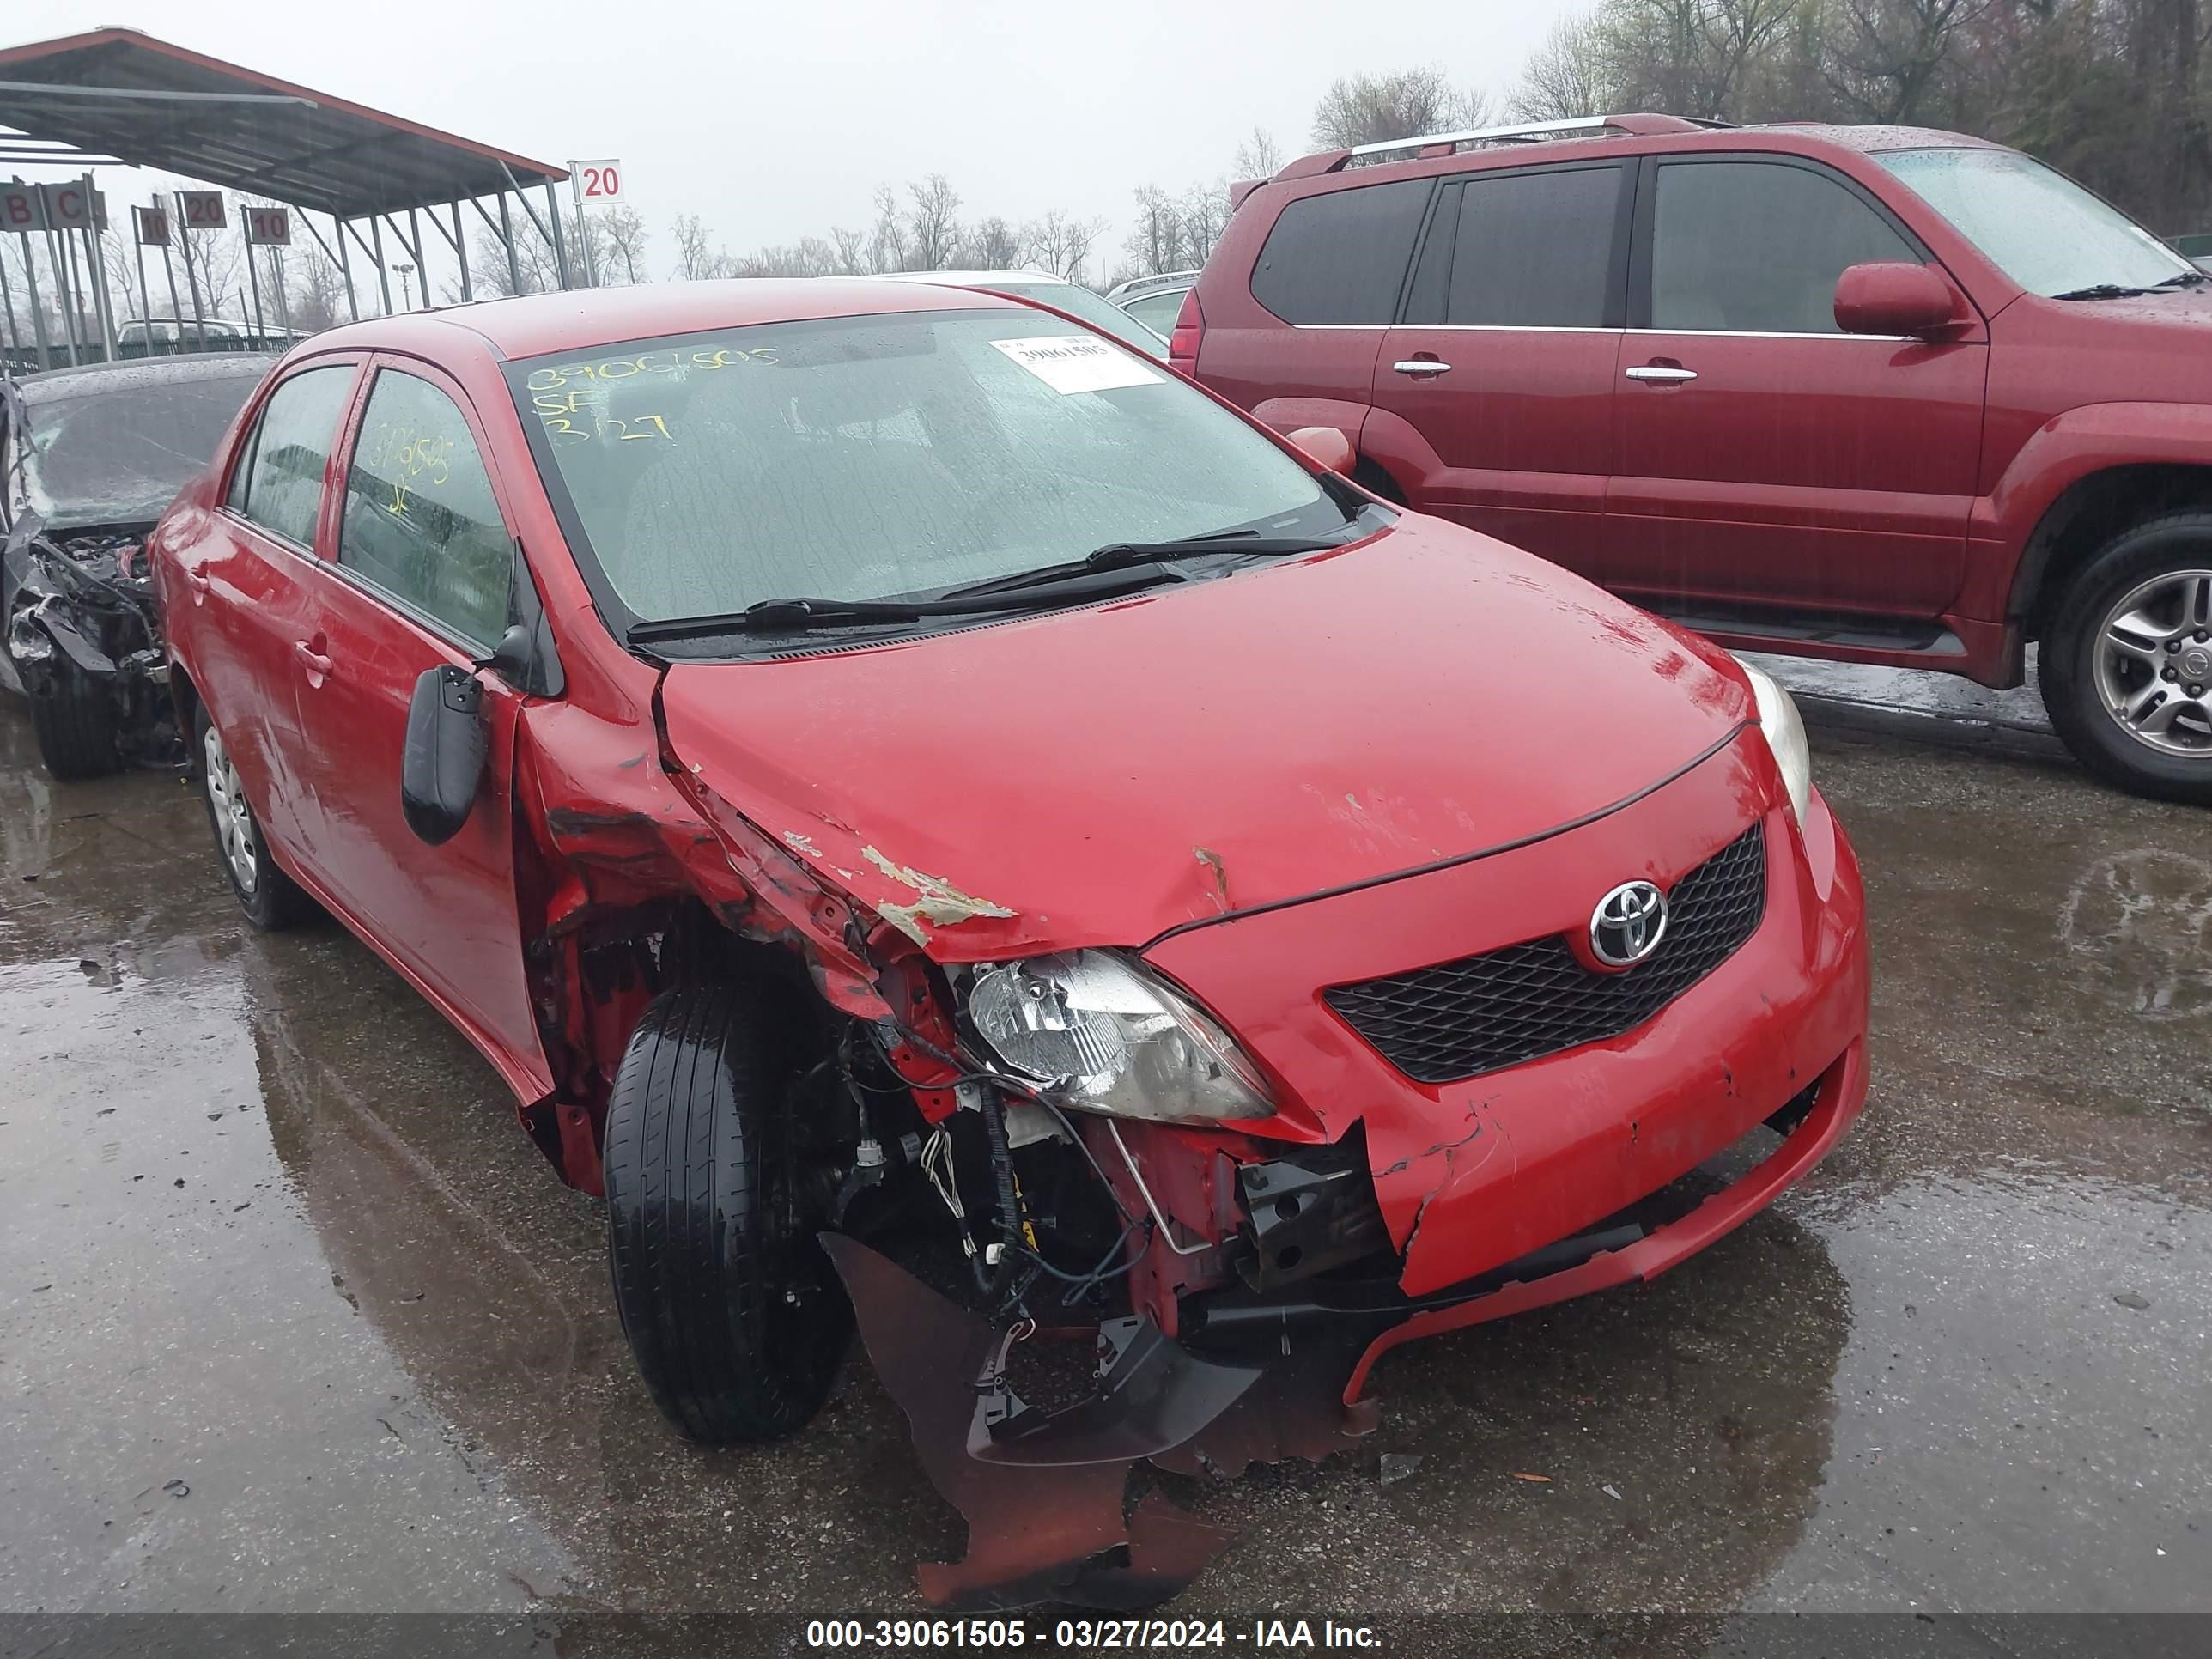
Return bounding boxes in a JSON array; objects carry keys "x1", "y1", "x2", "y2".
[{"x1": 2094, "y1": 571, "x2": 2212, "y2": 759}]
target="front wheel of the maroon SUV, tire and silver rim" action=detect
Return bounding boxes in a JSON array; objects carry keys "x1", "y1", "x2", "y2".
[{"x1": 2037, "y1": 508, "x2": 2212, "y2": 805}]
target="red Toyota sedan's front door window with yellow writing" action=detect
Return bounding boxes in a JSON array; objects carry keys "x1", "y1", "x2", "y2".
[{"x1": 338, "y1": 369, "x2": 514, "y2": 648}]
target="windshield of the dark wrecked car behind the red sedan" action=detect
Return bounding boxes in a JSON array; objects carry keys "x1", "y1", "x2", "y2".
[{"x1": 11, "y1": 362, "x2": 265, "y2": 529}]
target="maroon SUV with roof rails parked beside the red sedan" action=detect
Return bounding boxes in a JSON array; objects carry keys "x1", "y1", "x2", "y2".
[{"x1": 1172, "y1": 115, "x2": 2212, "y2": 801}]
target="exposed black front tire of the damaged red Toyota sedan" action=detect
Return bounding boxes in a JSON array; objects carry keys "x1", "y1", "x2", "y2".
[{"x1": 604, "y1": 978, "x2": 852, "y2": 1447}]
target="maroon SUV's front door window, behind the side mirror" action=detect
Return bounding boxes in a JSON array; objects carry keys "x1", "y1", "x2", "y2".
[{"x1": 1650, "y1": 161, "x2": 1924, "y2": 334}]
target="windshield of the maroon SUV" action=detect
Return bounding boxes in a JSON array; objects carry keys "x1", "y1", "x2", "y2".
[{"x1": 1874, "y1": 146, "x2": 2197, "y2": 296}]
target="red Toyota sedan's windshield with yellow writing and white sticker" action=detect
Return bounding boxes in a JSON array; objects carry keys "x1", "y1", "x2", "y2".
[{"x1": 508, "y1": 307, "x2": 1347, "y2": 622}]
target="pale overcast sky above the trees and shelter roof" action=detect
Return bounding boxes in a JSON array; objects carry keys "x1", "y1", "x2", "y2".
[{"x1": 0, "y1": 0, "x2": 1589, "y2": 276}]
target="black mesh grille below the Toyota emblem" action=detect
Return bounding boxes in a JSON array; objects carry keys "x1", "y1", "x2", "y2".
[{"x1": 1322, "y1": 825, "x2": 1767, "y2": 1084}]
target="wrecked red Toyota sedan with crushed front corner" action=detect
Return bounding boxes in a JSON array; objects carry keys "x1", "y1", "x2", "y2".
[{"x1": 153, "y1": 281, "x2": 1867, "y2": 1606}]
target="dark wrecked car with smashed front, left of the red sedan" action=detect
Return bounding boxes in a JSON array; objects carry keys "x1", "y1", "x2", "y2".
[{"x1": 0, "y1": 354, "x2": 274, "y2": 779}]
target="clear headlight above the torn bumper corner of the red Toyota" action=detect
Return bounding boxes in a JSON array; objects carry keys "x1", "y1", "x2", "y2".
[{"x1": 967, "y1": 951, "x2": 1274, "y2": 1124}]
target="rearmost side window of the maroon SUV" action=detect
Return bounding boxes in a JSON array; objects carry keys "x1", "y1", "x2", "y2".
[{"x1": 1252, "y1": 179, "x2": 1429, "y2": 327}]
